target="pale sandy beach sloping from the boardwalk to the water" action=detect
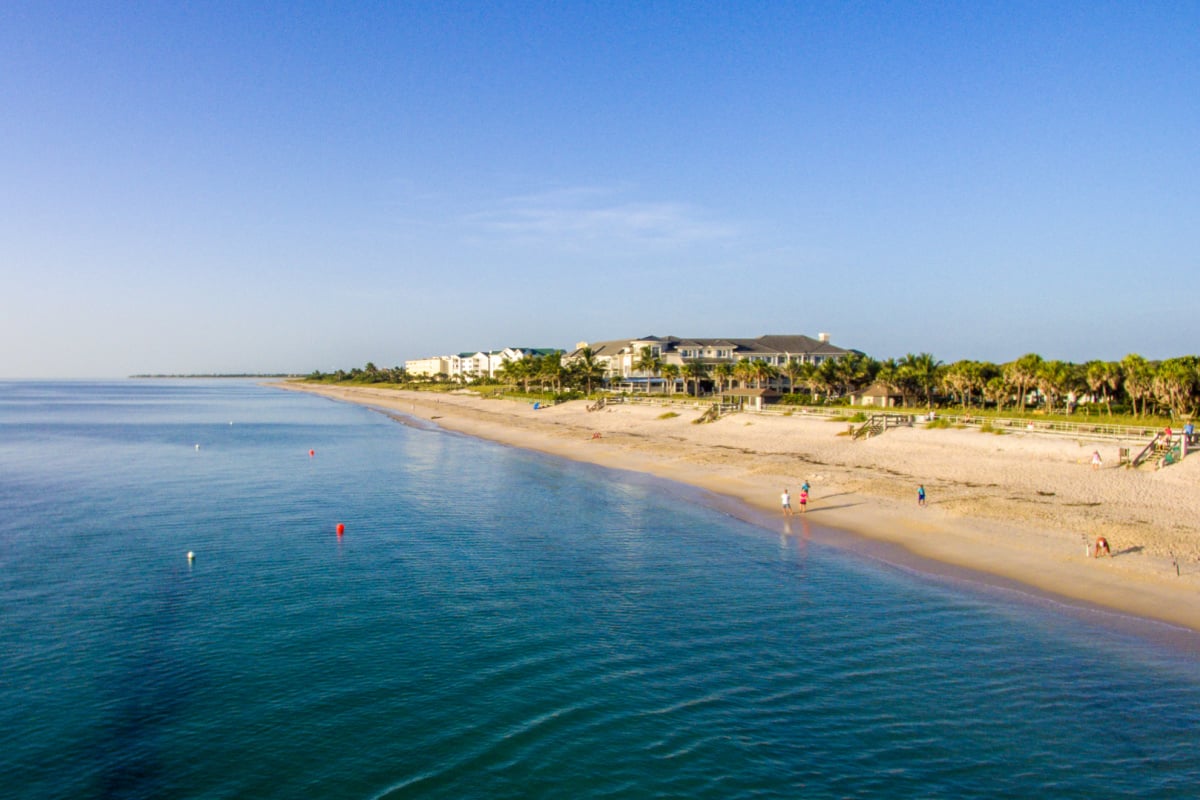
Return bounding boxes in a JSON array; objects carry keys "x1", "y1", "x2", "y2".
[{"x1": 280, "y1": 383, "x2": 1200, "y2": 632}]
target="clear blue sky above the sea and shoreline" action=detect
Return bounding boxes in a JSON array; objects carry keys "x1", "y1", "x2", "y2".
[{"x1": 0, "y1": 0, "x2": 1200, "y2": 378}]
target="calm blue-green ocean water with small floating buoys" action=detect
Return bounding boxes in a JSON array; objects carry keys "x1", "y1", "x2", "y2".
[{"x1": 0, "y1": 380, "x2": 1200, "y2": 799}]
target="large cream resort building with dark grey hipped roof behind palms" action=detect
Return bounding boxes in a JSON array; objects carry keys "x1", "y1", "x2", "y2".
[{"x1": 563, "y1": 333, "x2": 852, "y2": 384}]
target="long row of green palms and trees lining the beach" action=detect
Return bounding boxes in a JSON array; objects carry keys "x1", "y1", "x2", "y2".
[{"x1": 307, "y1": 348, "x2": 1200, "y2": 419}]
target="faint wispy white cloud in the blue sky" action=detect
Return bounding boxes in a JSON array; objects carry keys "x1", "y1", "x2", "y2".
[{"x1": 467, "y1": 187, "x2": 737, "y2": 249}]
